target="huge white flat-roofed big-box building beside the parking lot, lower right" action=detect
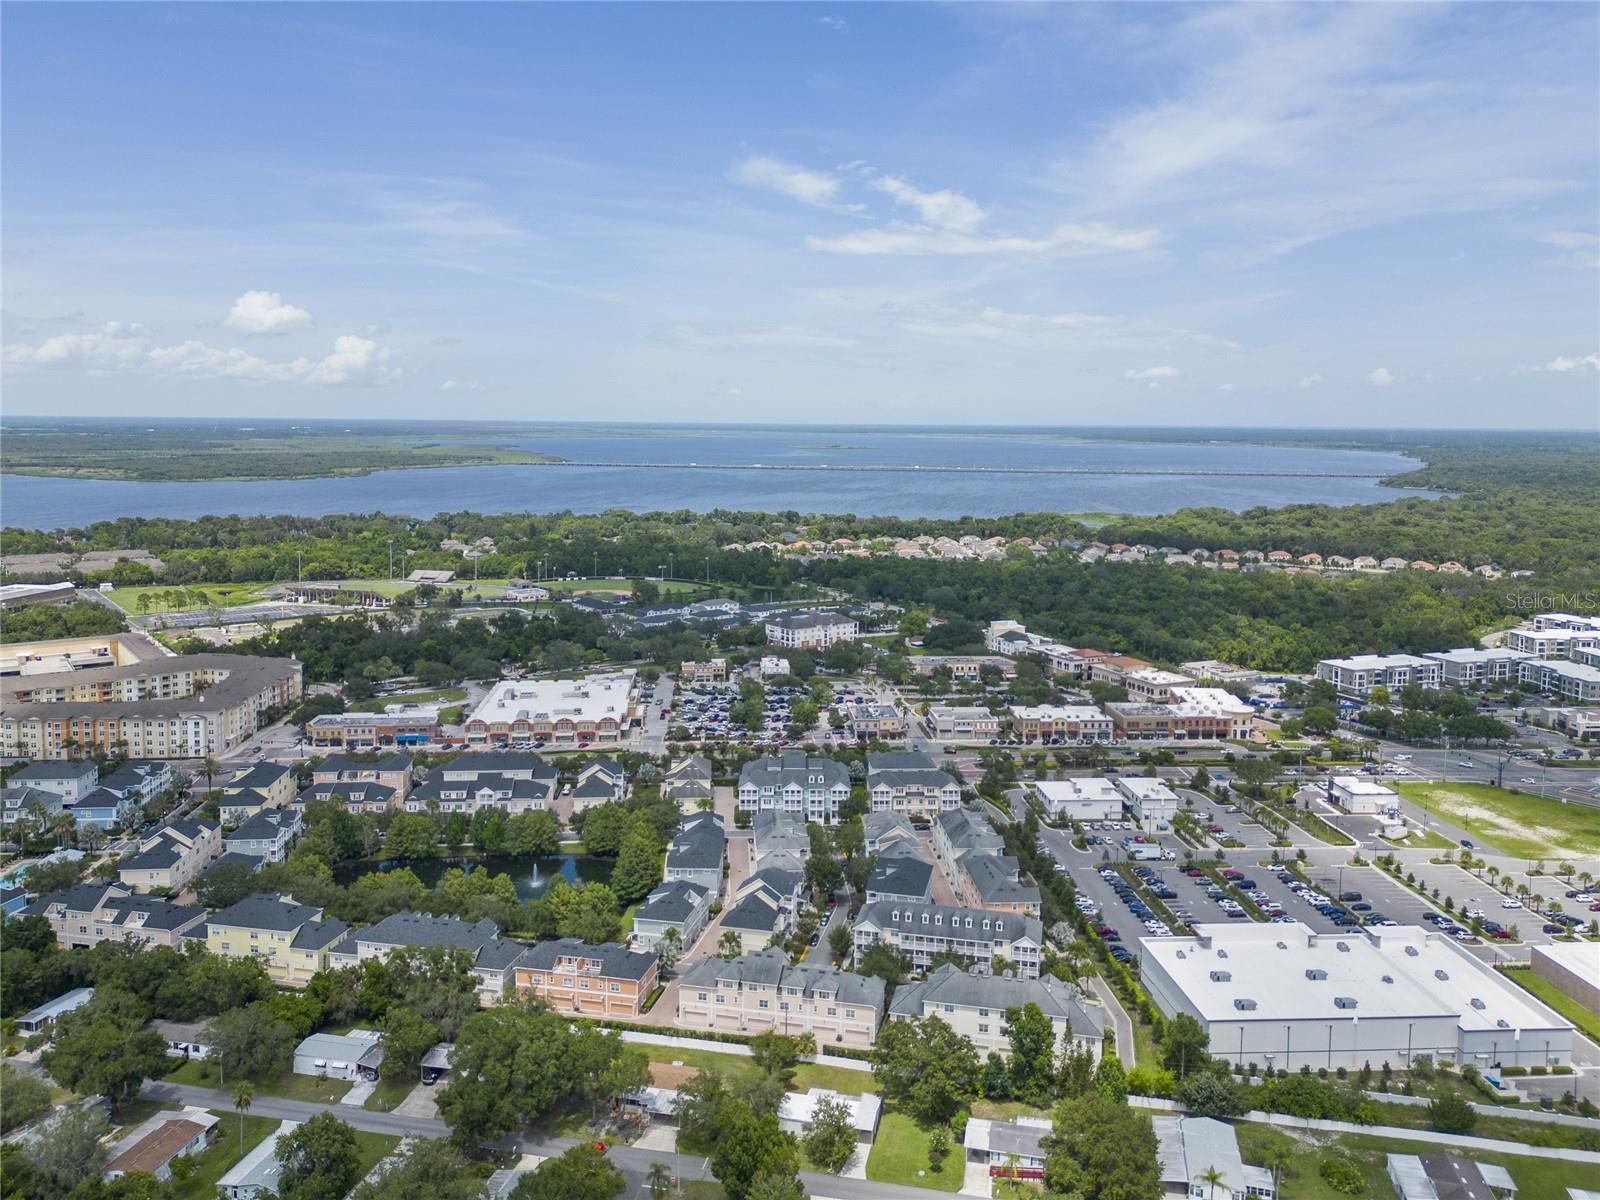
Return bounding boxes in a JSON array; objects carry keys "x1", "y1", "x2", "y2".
[{"x1": 1139, "y1": 922, "x2": 1573, "y2": 1070}]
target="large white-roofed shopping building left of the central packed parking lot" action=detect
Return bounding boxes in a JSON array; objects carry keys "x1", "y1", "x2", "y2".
[{"x1": 466, "y1": 670, "x2": 642, "y2": 747}]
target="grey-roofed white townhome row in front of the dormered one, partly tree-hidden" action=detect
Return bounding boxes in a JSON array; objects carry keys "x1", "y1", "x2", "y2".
[{"x1": 890, "y1": 963, "x2": 1106, "y2": 1062}]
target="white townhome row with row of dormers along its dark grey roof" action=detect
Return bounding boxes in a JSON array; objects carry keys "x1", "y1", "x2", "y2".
[{"x1": 851, "y1": 901, "x2": 1045, "y2": 979}]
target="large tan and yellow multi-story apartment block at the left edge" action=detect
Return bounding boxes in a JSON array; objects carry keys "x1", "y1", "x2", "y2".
[{"x1": 0, "y1": 654, "x2": 301, "y2": 758}]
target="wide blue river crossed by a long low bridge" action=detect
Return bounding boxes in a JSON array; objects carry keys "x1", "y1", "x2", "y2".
[{"x1": 0, "y1": 426, "x2": 1434, "y2": 530}]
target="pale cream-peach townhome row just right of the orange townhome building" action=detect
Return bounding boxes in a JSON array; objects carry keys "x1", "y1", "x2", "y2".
[{"x1": 674, "y1": 950, "x2": 885, "y2": 1048}]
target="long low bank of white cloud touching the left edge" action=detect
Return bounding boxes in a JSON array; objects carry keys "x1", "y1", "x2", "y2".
[{"x1": 5, "y1": 322, "x2": 400, "y2": 386}]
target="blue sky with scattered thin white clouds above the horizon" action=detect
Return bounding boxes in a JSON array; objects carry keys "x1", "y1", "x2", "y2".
[{"x1": 0, "y1": 3, "x2": 1600, "y2": 429}]
